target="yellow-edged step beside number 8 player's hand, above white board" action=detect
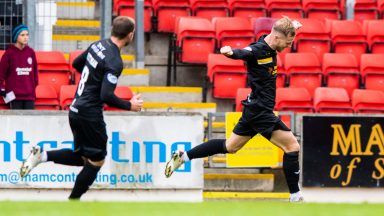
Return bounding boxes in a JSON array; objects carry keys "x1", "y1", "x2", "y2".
[{"x1": 130, "y1": 86, "x2": 204, "y2": 103}]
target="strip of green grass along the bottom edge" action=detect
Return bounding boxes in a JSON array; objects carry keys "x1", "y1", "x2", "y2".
[{"x1": 0, "y1": 201, "x2": 384, "y2": 216}]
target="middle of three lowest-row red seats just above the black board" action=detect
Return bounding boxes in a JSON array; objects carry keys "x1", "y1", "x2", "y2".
[{"x1": 313, "y1": 87, "x2": 353, "y2": 113}]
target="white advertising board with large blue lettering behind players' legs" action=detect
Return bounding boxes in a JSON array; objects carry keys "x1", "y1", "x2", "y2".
[{"x1": 0, "y1": 111, "x2": 204, "y2": 201}]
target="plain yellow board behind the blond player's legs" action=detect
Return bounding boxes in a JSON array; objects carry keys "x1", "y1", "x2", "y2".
[{"x1": 225, "y1": 112, "x2": 283, "y2": 167}]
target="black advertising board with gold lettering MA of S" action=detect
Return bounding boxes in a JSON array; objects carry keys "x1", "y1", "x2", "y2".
[{"x1": 302, "y1": 116, "x2": 384, "y2": 187}]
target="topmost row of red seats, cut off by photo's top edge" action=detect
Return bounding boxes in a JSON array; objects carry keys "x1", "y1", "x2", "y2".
[{"x1": 113, "y1": 0, "x2": 384, "y2": 32}]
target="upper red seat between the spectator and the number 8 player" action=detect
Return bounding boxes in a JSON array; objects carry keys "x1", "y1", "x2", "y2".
[{"x1": 36, "y1": 51, "x2": 71, "y2": 93}]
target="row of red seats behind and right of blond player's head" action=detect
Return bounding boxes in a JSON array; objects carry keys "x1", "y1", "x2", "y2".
[{"x1": 253, "y1": 17, "x2": 384, "y2": 58}]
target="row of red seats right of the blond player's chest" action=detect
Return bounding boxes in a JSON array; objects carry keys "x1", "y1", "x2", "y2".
[{"x1": 277, "y1": 53, "x2": 384, "y2": 95}]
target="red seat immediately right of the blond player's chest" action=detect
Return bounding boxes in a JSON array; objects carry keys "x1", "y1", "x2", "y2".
[{"x1": 284, "y1": 53, "x2": 322, "y2": 95}]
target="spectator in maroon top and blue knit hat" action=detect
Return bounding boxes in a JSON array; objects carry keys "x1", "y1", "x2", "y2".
[{"x1": 0, "y1": 24, "x2": 38, "y2": 109}]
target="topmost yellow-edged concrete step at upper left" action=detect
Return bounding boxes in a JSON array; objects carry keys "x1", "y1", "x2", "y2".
[{"x1": 56, "y1": 1, "x2": 96, "y2": 20}]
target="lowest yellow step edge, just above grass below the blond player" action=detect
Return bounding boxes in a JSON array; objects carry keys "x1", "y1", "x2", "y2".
[{"x1": 203, "y1": 191, "x2": 289, "y2": 200}]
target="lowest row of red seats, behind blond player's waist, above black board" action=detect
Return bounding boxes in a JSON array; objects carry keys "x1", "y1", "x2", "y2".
[{"x1": 236, "y1": 87, "x2": 384, "y2": 113}]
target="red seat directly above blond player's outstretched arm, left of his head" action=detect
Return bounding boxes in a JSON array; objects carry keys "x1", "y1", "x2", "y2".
[{"x1": 212, "y1": 17, "x2": 255, "y2": 48}]
